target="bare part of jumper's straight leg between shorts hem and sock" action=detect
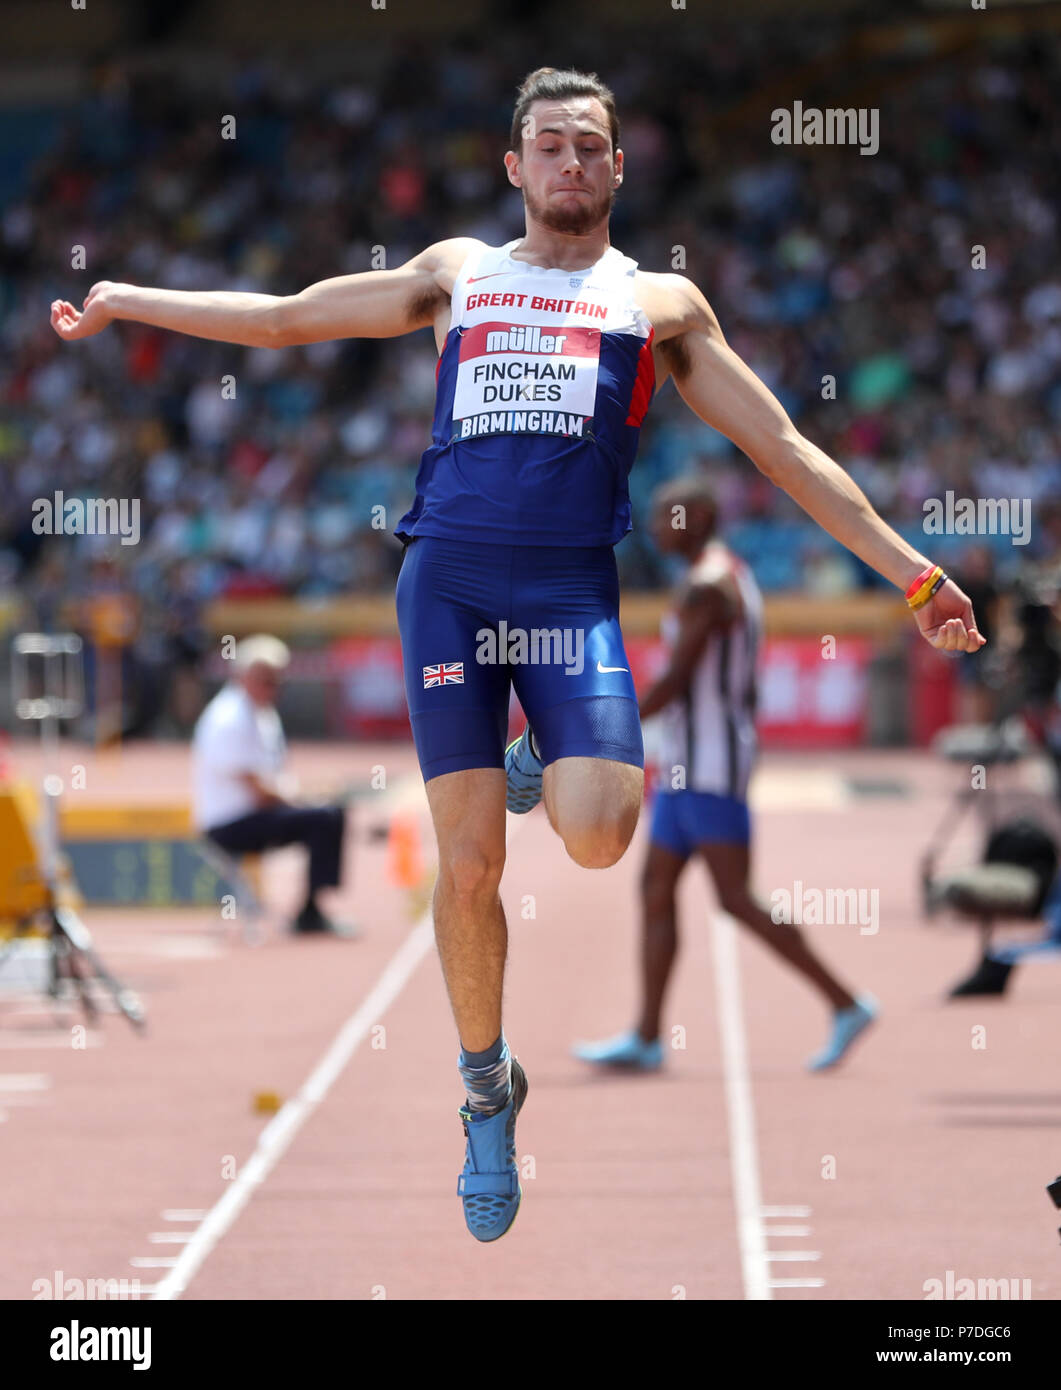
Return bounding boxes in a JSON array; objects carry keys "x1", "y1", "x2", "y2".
[{"x1": 427, "y1": 767, "x2": 508, "y2": 1052}]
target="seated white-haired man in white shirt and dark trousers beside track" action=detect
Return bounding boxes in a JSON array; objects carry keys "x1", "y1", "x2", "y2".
[{"x1": 192, "y1": 637, "x2": 353, "y2": 935}]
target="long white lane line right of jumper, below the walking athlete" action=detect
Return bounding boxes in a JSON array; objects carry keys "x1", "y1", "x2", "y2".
[{"x1": 711, "y1": 912, "x2": 772, "y2": 1300}]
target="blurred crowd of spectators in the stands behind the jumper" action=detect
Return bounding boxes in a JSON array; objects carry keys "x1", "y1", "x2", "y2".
[{"x1": 0, "y1": 22, "x2": 1061, "y2": 636}]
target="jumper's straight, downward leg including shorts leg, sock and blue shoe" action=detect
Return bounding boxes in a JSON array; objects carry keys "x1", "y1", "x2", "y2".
[{"x1": 396, "y1": 538, "x2": 527, "y2": 1241}]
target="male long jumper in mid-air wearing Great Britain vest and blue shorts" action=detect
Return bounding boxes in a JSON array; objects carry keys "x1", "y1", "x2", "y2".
[{"x1": 51, "y1": 68, "x2": 983, "y2": 1241}]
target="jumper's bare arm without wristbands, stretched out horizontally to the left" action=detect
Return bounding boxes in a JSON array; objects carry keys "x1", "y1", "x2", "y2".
[{"x1": 51, "y1": 238, "x2": 473, "y2": 348}]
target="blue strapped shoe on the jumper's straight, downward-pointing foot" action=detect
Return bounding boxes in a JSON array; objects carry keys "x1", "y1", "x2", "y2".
[{"x1": 457, "y1": 1056, "x2": 527, "y2": 1241}]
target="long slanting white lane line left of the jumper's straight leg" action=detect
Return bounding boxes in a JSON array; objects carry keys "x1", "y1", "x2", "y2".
[{"x1": 152, "y1": 908, "x2": 434, "y2": 1301}]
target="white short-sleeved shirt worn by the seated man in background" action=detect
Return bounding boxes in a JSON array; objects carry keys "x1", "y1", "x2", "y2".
[{"x1": 192, "y1": 682, "x2": 286, "y2": 830}]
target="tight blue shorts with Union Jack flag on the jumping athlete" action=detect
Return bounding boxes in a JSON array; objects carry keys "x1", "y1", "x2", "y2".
[{"x1": 396, "y1": 535, "x2": 644, "y2": 781}]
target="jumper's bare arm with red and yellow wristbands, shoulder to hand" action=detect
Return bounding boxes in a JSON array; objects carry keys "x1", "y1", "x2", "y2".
[{"x1": 661, "y1": 275, "x2": 985, "y2": 652}]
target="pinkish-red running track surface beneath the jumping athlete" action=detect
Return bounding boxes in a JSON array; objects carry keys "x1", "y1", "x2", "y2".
[{"x1": 0, "y1": 746, "x2": 1061, "y2": 1300}]
